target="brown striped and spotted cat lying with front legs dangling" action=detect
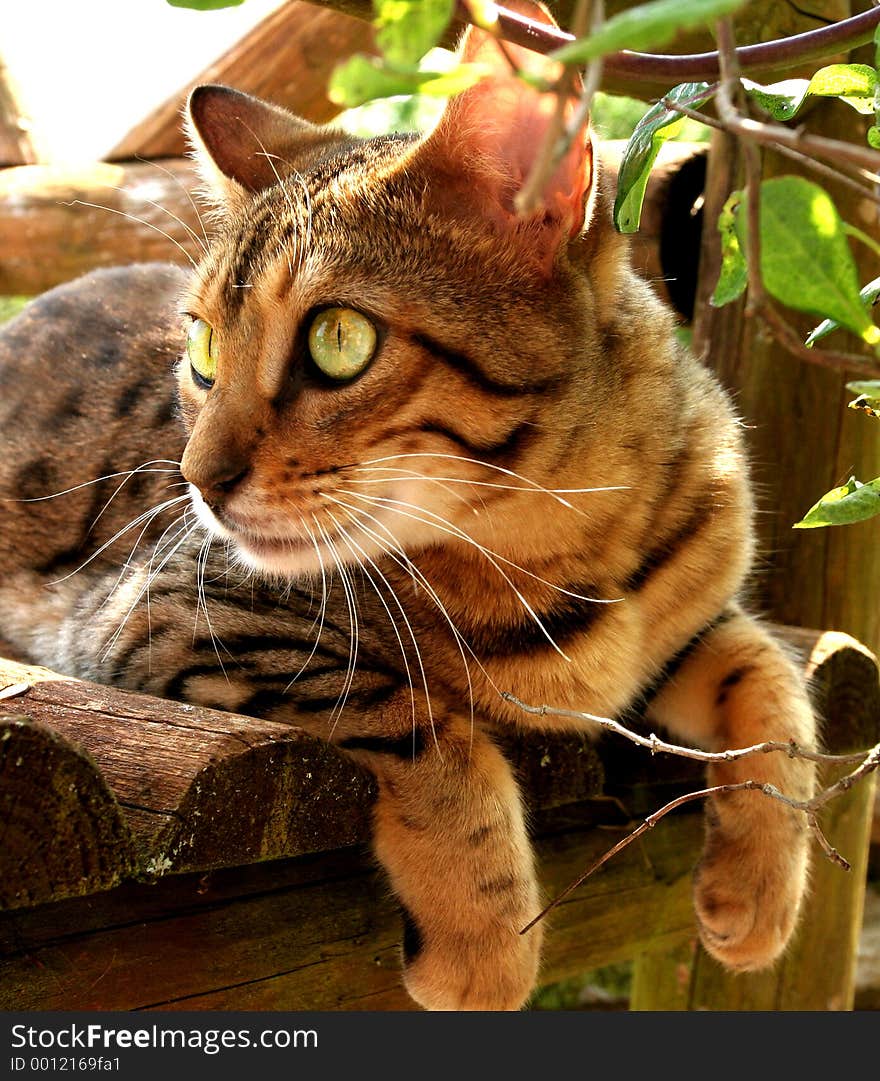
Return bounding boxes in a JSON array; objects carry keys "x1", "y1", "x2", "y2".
[{"x1": 0, "y1": 10, "x2": 814, "y2": 1010}]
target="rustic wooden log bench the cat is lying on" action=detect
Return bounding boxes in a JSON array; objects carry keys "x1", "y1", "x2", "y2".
[{"x1": 0, "y1": 630, "x2": 880, "y2": 1010}]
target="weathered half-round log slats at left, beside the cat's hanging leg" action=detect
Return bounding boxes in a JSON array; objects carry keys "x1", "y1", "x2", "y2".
[{"x1": 0, "y1": 662, "x2": 373, "y2": 904}]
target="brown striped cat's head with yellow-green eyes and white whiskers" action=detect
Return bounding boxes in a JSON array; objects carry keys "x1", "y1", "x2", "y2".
[{"x1": 179, "y1": 2, "x2": 594, "y2": 575}]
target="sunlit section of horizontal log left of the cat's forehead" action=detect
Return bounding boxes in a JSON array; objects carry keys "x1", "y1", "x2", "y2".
[{"x1": 0, "y1": 161, "x2": 205, "y2": 296}]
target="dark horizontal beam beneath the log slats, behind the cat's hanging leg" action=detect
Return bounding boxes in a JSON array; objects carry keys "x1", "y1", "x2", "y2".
[{"x1": 0, "y1": 813, "x2": 702, "y2": 1010}]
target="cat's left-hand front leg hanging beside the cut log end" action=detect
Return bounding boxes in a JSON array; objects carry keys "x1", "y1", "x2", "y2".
[{"x1": 341, "y1": 696, "x2": 542, "y2": 1010}]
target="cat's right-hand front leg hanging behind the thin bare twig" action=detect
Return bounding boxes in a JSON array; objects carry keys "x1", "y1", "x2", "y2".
[{"x1": 649, "y1": 609, "x2": 815, "y2": 970}]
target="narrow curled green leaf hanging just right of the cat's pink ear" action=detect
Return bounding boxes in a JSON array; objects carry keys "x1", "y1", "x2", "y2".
[{"x1": 614, "y1": 82, "x2": 714, "y2": 232}]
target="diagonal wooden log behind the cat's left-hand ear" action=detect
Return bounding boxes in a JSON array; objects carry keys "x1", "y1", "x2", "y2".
[{"x1": 107, "y1": 2, "x2": 375, "y2": 161}]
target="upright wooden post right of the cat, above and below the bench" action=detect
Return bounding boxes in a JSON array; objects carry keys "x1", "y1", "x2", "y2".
[{"x1": 637, "y1": 2, "x2": 880, "y2": 1010}]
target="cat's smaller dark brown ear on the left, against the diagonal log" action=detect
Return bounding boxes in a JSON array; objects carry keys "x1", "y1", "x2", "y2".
[{"x1": 185, "y1": 85, "x2": 341, "y2": 206}]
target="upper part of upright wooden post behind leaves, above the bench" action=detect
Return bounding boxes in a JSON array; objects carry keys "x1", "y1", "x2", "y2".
[{"x1": 694, "y1": 3, "x2": 880, "y2": 652}]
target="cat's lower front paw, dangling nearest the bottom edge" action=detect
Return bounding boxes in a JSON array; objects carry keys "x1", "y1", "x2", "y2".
[{"x1": 403, "y1": 926, "x2": 542, "y2": 1011}]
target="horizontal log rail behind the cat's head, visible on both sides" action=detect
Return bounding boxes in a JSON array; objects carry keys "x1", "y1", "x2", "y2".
[{"x1": 0, "y1": 142, "x2": 705, "y2": 310}]
